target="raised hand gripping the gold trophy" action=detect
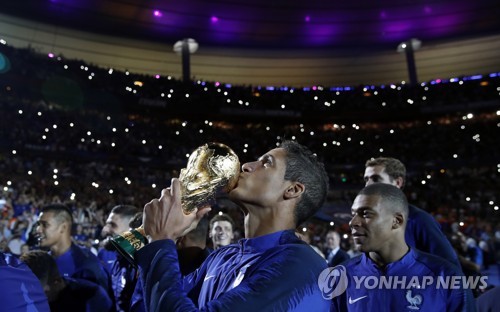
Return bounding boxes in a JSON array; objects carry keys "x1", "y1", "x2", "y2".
[{"x1": 142, "y1": 178, "x2": 211, "y2": 242}]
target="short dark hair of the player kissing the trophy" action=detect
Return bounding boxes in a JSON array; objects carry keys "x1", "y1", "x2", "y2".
[{"x1": 278, "y1": 140, "x2": 328, "y2": 226}]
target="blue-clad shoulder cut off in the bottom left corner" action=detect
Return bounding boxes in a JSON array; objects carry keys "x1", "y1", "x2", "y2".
[{"x1": 0, "y1": 252, "x2": 50, "y2": 312}]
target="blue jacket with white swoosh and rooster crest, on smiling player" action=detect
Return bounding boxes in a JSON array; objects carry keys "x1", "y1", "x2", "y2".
[{"x1": 332, "y1": 248, "x2": 474, "y2": 311}]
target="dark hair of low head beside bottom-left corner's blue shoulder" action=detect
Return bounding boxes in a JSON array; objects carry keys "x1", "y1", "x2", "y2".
[{"x1": 19, "y1": 250, "x2": 61, "y2": 285}]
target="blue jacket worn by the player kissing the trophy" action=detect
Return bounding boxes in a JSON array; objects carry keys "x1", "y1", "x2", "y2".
[{"x1": 136, "y1": 230, "x2": 330, "y2": 312}]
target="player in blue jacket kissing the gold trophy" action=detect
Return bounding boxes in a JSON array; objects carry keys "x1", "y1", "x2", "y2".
[{"x1": 136, "y1": 141, "x2": 330, "y2": 312}]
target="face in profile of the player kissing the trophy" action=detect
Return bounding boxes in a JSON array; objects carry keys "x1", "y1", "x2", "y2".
[{"x1": 229, "y1": 148, "x2": 289, "y2": 207}]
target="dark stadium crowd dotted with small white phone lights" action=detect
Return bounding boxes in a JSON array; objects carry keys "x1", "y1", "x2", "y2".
[{"x1": 0, "y1": 42, "x2": 500, "y2": 310}]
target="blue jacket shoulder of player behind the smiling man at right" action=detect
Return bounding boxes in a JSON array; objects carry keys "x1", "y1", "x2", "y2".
[{"x1": 405, "y1": 205, "x2": 461, "y2": 268}]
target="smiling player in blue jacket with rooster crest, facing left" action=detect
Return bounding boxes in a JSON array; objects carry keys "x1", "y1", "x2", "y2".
[{"x1": 330, "y1": 183, "x2": 474, "y2": 311}]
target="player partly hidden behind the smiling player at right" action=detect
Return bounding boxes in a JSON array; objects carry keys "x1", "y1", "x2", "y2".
[{"x1": 364, "y1": 157, "x2": 461, "y2": 269}]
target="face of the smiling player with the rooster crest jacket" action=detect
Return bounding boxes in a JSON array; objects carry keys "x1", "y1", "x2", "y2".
[{"x1": 349, "y1": 195, "x2": 393, "y2": 252}]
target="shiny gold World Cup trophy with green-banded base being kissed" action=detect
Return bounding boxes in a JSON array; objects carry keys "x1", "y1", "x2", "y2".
[{"x1": 111, "y1": 143, "x2": 240, "y2": 266}]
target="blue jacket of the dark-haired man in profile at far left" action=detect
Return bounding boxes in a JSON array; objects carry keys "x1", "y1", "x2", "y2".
[{"x1": 55, "y1": 244, "x2": 111, "y2": 294}]
